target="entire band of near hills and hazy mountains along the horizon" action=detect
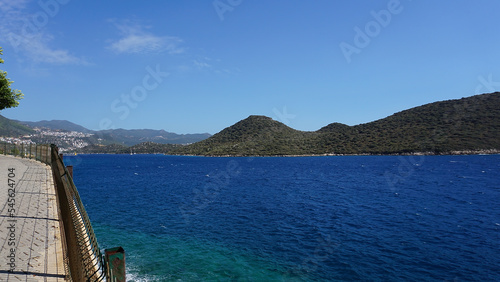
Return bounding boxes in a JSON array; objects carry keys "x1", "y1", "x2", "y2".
[{"x1": 0, "y1": 92, "x2": 500, "y2": 156}]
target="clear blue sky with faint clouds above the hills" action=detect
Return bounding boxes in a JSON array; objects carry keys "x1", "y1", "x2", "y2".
[{"x1": 0, "y1": 0, "x2": 500, "y2": 134}]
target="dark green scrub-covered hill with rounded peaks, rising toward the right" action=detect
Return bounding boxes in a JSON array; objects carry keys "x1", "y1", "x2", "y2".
[{"x1": 174, "y1": 92, "x2": 500, "y2": 156}]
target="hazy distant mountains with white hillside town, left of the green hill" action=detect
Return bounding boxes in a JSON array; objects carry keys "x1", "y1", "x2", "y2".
[{"x1": 0, "y1": 115, "x2": 211, "y2": 153}]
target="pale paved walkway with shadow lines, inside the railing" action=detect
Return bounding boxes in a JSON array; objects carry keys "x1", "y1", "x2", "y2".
[{"x1": 0, "y1": 155, "x2": 67, "y2": 281}]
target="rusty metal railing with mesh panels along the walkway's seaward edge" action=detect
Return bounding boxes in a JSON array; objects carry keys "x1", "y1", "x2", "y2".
[{"x1": 0, "y1": 143, "x2": 125, "y2": 282}]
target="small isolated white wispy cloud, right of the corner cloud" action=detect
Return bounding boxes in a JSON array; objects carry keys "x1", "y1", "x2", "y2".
[{"x1": 108, "y1": 20, "x2": 184, "y2": 54}]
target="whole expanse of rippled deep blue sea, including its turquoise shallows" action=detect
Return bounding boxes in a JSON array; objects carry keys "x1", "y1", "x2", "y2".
[{"x1": 64, "y1": 155, "x2": 500, "y2": 281}]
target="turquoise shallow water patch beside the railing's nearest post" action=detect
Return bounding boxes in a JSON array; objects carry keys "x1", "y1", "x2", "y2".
[{"x1": 95, "y1": 224, "x2": 292, "y2": 281}]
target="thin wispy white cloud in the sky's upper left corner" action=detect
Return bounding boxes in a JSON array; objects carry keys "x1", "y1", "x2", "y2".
[{"x1": 0, "y1": 0, "x2": 88, "y2": 65}]
